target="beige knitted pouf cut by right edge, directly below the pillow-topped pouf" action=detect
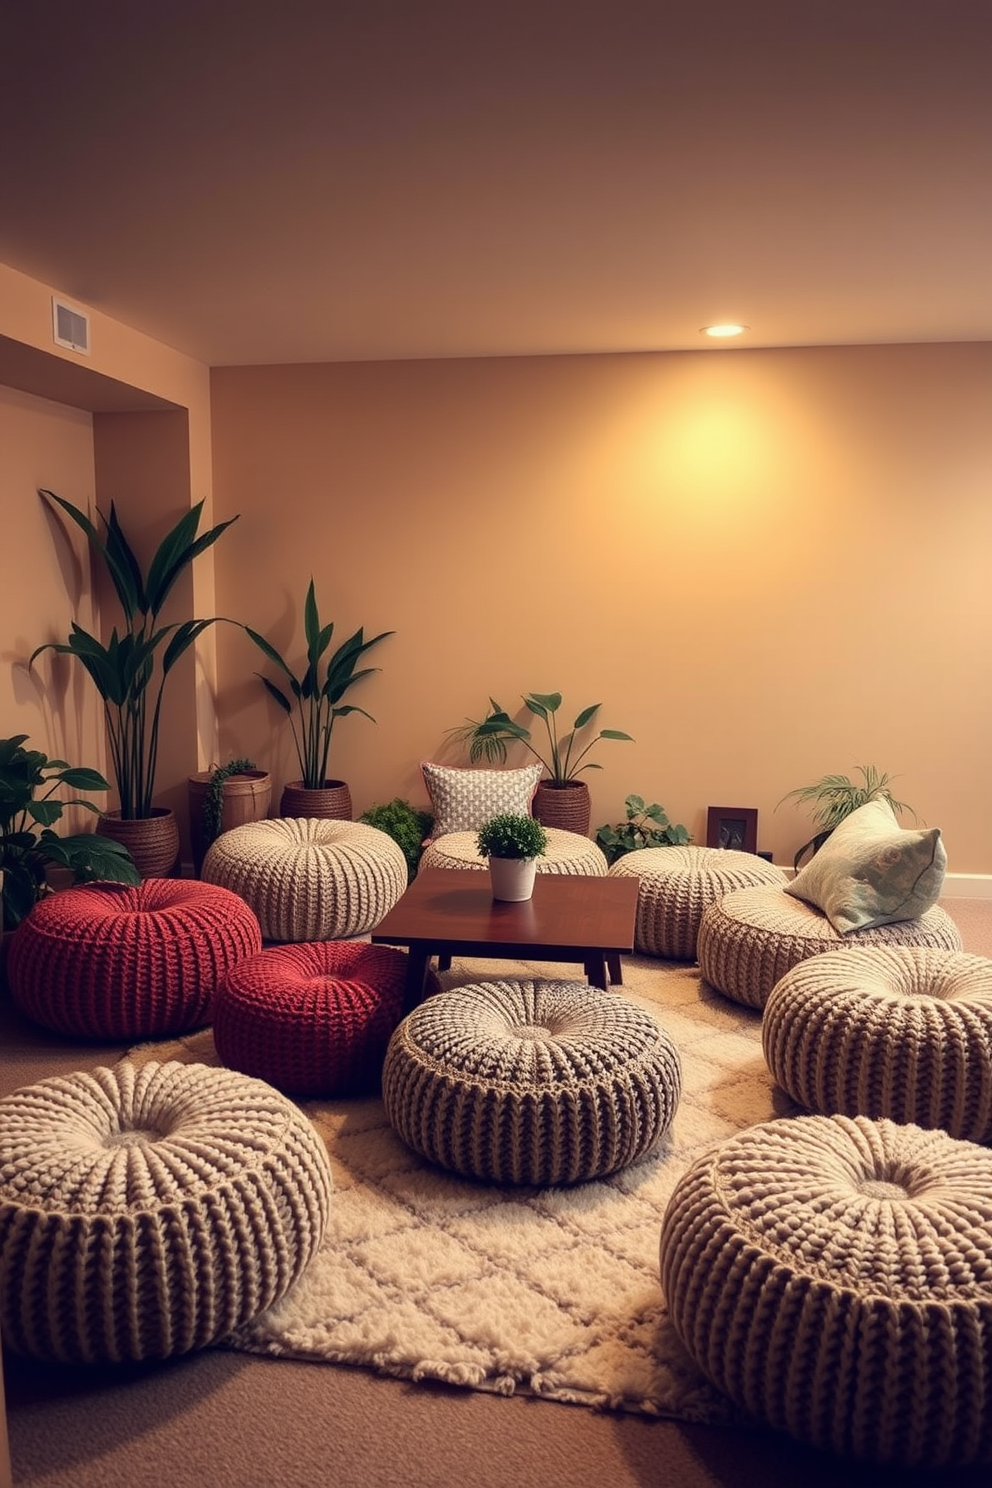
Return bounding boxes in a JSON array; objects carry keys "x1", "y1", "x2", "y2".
[{"x1": 761, "y1": 945, "x2": 992, "y2": 1143}]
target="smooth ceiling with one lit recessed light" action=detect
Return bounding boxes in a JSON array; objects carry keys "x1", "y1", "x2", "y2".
[{"x1": 0, "y1": 0, "x2": 992, "y2": 365}]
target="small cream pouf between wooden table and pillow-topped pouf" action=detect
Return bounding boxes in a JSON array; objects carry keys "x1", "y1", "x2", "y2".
[{"x1": 610, "y1": 845, "x2": 785, "y2": 961}]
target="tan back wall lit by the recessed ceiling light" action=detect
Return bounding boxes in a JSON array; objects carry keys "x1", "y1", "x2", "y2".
[{"x1": 211, "y1": 345, "x2": 992, "y2": 873}]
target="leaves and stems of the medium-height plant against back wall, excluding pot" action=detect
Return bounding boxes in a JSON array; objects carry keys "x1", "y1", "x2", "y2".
[{"x1": 245, "y1": 577, "x2": 394, "y2": 790}]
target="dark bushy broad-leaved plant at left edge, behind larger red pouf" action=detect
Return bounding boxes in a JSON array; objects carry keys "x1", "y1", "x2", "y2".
[{"x1": 0, "y1": 734, "x2": 138, "y2": 930}]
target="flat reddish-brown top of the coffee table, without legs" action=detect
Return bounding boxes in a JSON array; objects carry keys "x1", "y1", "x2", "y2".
[{"x1": 372, "y1": 868, "x2": 638, "y2": 954}]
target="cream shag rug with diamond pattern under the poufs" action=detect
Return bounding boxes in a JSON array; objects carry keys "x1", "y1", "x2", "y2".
[{"x1": 128, "y1": 957, "x2": 797, "y2": 1424}]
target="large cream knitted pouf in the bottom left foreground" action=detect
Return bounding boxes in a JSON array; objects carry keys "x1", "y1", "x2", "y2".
[{"x1": 0, "y1": 1061, "x2": 332, "y2": 1363}]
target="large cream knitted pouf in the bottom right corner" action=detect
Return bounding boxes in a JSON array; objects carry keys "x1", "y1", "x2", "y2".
[{"x1": 660, "y1": 1116, "x2": 992, "y2": 1467}]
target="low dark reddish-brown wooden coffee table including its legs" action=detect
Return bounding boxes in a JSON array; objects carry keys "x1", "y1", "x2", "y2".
[{"x1": 372, "y1": 868, "x2": 638, "y2": 1006}]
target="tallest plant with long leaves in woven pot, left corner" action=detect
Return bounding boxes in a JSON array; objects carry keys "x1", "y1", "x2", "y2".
[{"x1": 31, "y1": 490, "x2": 236, "y2": 878}]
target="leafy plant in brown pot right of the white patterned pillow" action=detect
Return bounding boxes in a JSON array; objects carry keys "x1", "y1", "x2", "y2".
[{"x1": 451, "y1": 692, "x2": 632, "y2": 836}]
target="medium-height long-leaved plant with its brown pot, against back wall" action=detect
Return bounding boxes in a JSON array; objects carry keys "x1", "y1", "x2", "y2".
[{"x1": 245, "y1": 577, "x2": 394, "y2": 820}]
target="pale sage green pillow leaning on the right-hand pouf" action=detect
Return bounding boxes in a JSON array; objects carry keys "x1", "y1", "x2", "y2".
[{"x1": 785, "y1": 798, "x2": 947, "y2": 934}]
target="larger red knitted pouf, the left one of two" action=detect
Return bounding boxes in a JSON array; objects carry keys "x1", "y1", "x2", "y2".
[{"x1": 7, "y1": 878, "x2": 262, "y2": 1039}]
